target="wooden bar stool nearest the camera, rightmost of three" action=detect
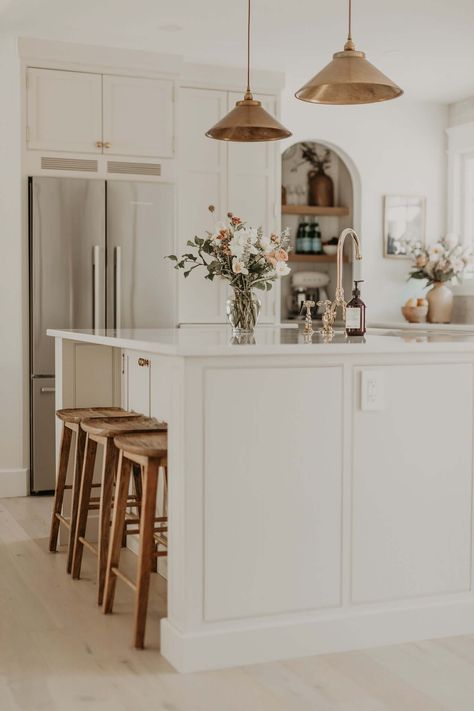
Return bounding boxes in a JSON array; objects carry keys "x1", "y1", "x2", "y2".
[{"x1": 104, "y1": 432, "x2": 168, "y2": 649}]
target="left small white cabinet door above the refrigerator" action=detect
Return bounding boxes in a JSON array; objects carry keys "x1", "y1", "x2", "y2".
[{"x1": 27, "y1": 68, "x2": 102, "y2": 153}]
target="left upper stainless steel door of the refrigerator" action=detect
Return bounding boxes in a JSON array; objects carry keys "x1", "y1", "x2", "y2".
[{"x1": 29, "y1": 178, "x2": 105, "y2": 375}]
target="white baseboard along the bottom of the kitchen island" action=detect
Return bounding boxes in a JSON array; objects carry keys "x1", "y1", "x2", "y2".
[{"x1": 161, "y1": 599, "x2": 474, "y2": 673}]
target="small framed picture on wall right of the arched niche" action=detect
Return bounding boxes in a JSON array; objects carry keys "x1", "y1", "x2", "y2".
[{"x1": 383, "y1": 195, "x2": 426, "y2": 259}]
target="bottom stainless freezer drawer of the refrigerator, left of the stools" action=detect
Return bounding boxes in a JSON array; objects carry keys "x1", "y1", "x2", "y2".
[{"x1": 30, "y1": 378, "x2": 56, "y2": 493}]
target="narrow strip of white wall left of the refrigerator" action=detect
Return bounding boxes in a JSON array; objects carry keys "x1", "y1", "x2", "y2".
[{"x1": 0, "y1": 35, "x2": 28, "y2": 496}]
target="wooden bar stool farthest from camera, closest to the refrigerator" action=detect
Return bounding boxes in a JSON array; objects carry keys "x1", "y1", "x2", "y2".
[{"x1": 49, "y1": 407, "x2": 138, "y2": 573}]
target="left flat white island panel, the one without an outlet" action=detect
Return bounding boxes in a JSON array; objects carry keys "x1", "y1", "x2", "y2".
[{"x1": 203, "y1": 365, "x2": 343, "y2": 621}]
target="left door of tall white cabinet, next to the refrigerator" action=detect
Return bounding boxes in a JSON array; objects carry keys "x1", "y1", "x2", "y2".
[{"x1": 176, "y1": 88, "x2": 227, "y2": 323}]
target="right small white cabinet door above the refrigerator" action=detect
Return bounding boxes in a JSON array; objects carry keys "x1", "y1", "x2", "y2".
[{"x1": 103, "y1": 75, "x2": 174, "y2": 158}]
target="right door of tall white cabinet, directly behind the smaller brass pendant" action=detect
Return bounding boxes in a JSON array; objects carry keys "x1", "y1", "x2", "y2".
[{"x1": 227, "y1": 93, "x2": 279, "y2": 323}]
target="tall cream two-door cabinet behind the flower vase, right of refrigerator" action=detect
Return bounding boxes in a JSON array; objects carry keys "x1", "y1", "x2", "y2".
[{"x1": 176, "y1": 88, "x2": 279, "y2": 324}]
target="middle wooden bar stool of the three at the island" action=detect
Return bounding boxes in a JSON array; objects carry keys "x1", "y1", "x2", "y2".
[{"x1": 72, "y1": 415, "x2": 167, "y2": 605}]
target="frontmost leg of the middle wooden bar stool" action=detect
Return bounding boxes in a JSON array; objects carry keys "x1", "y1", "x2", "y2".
[{"x1": 97, "y1": 440, "x2": 118, "y2": 605}]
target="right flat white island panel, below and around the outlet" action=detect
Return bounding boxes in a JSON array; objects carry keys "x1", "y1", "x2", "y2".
[{"x1": 351, "y1": 363, "x2": 474, "y2": 604}]
